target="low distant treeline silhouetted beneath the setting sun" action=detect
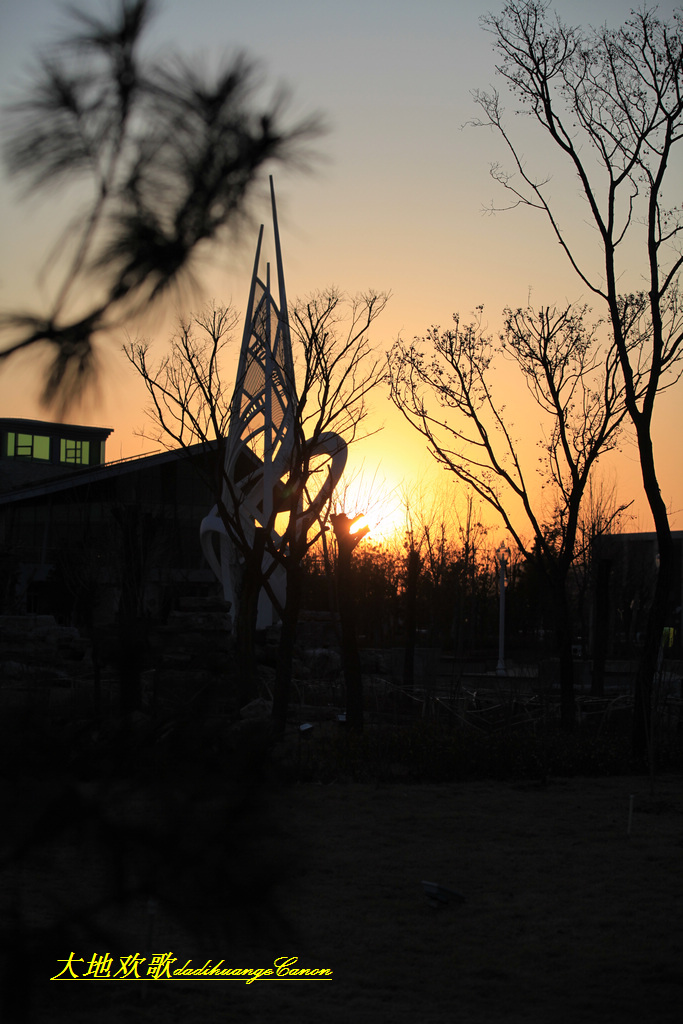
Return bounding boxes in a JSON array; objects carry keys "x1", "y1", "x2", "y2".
[{"x1": 302, "y1": 486, "x2": 644, "y2": 684}]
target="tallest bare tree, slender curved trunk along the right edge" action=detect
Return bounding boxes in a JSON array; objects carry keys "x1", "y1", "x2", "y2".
[{"x1": 475, "y1": 0, "x2": 683, "y2": 754}]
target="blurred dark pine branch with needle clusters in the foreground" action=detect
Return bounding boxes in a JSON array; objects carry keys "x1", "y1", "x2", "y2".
[{"x1": 0, "y1": 0, "x2": 317, "y2": 404}]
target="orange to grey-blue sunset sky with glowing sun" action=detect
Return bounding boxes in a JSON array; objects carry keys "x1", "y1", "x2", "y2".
[{"x1": 0, "y1": 0, "x2": 683, "y2": 530}]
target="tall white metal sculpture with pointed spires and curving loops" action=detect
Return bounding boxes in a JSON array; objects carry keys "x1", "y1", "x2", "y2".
[{"x1": 200, "y1": 178, "x2": 347, "y2": 628}]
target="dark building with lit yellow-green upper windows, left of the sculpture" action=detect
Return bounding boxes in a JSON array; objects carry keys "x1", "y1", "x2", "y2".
[{"x1": 0, "y1": 419, "x2": 218, "y2": 626}]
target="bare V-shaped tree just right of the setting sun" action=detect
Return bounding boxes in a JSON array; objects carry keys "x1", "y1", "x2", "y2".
[{"x1": 389, "y1": 306, "x2": 626, "y2": 729}]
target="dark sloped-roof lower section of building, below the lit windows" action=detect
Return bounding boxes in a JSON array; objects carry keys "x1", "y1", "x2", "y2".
[{"x1": 0, "y1": 453, "x2": 222, "y2": 625}]
